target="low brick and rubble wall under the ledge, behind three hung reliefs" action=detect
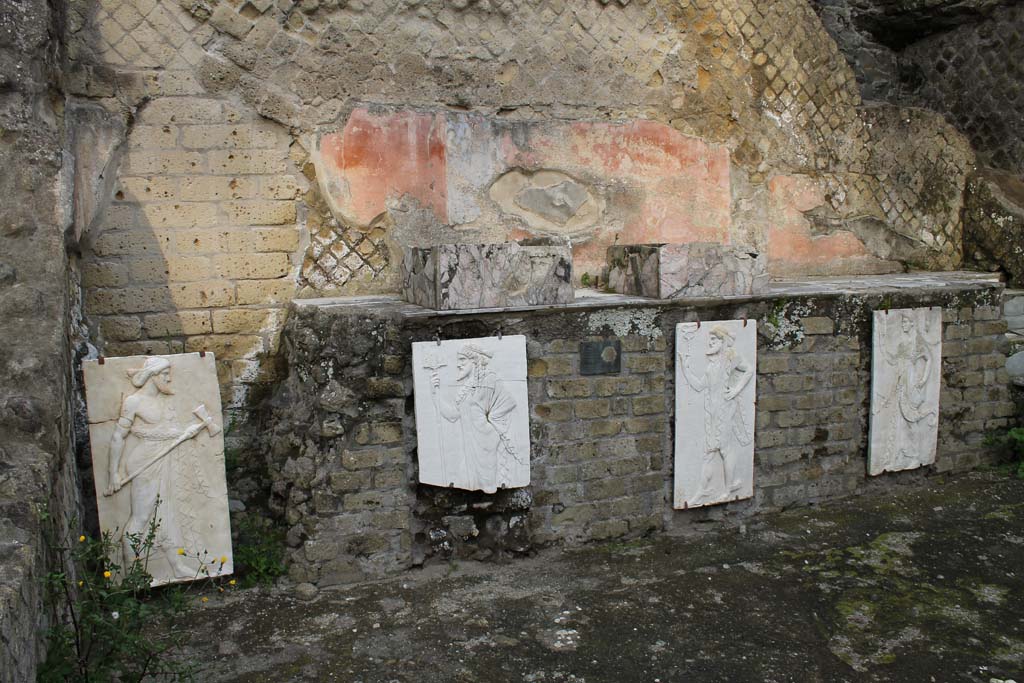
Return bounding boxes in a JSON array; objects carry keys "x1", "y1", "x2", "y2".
[{"x1": 267, "y1": 273, "x2": 1014, "y2": 586}]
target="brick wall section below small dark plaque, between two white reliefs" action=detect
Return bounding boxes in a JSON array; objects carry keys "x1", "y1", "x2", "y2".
[{"x1": 528, "y1": 335, "x2": 671, "y2": 544}]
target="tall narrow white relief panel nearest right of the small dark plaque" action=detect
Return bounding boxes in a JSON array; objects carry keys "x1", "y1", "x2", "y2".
[{"x1": 674, "y1": 321, "x2": 757, "y2": 509}]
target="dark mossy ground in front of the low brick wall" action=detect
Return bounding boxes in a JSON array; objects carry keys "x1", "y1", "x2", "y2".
[{"x1": 180, "y1": 472, "x2": 1024, "y2": 683}]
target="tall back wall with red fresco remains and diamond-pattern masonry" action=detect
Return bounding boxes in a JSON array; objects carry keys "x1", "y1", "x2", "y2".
[{"x1": 62, "y1": 0, "x2": 991, "y2": 450}]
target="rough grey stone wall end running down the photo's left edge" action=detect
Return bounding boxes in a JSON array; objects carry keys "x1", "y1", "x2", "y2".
[{"x1": 0, "y1": 0, "x2": 81, "y2": 681}]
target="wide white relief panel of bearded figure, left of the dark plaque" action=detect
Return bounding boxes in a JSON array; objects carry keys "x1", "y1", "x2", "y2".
[{"x1": 413, "y1": 335, "x2": 529, "y2": 494}]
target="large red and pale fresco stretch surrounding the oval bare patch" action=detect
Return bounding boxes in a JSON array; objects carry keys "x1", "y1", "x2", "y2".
[{"x1": 317, "y1": 109, "x2": 731, "y2": 273}]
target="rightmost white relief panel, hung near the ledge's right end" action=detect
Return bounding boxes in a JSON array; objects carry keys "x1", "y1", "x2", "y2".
[{"x1": 867, "y1": 306, "x2": 942, "y2": 475}]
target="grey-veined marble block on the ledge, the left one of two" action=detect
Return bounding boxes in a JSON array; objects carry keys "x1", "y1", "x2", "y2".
[{"x1": 401, "y1": 242, "x2": 574, "y2": 310}]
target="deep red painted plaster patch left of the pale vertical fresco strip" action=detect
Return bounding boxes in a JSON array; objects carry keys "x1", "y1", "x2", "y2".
[{"x1": 319, "y1": 109, "x2": 447, "y2": 225}]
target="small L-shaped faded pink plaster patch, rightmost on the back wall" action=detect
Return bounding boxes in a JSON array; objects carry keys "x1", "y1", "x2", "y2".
[{"x1": 765, "y1": 175, "x2": 881, "y2": 276}]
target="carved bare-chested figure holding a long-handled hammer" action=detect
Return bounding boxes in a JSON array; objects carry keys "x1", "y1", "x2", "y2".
[{"x1": 103, "y1": 357, "x2": 220, "y2": 579}]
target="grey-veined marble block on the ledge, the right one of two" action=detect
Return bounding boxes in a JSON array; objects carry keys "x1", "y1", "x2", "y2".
[{"x1": 607, "y1": 242, "x2": 768, "y2": 299}]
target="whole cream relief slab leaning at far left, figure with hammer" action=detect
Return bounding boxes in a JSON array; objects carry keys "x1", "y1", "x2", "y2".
[{"x1": 83, "y1": 353, "x2": 233, "y2": 586}]
